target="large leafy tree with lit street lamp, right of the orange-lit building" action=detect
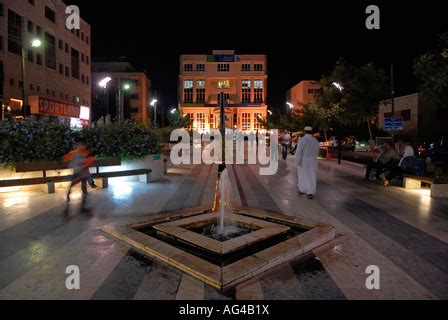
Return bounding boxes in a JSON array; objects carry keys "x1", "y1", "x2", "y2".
[{"x1": 320, "y1": 61, "x2": 388, "y2": 140}]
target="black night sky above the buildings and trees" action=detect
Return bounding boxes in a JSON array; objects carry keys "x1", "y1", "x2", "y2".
[{"x1": 66, "y1": 0, "x2": 448, "y2": 110}]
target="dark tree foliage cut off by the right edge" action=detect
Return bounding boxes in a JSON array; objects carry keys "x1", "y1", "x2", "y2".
[{"x1": 414, "y1": 32, "x2": 448, "y2": 108}]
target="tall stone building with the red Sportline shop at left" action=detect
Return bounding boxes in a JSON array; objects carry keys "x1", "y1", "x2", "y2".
[{"x1": 0, "y1": 0, "x2": 91, "y2": 123}]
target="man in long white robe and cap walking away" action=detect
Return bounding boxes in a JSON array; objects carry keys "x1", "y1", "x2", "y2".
[{"x1": 296, "y1": 126, "x2": 319, "y2": 200}]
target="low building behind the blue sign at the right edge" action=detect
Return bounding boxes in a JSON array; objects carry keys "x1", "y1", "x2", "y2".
[{"x1": 378, "y1": 93, "x2": 448, "y2": 142}]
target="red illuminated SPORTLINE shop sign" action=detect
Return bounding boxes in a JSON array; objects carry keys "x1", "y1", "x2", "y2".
[{"x1": 29, "y1": 96, "x2": 81, "y2": 118}]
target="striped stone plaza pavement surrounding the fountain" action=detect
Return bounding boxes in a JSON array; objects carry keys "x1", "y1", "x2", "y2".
[{"x1": 0, "y1": 159, "x2": 448, "y2": 300}]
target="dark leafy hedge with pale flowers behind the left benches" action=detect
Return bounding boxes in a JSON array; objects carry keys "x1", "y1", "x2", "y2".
[{"x1": 0, "y1": 121, "x2": 159, "y2": 166}]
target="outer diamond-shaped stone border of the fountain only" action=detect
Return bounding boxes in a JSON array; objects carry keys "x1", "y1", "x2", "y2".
[{"x1": 102, "y1": 206, "x2": 335, "y2": 291}]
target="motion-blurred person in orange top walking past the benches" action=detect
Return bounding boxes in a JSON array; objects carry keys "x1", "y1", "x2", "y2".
[{"x1": 63, "y1": 140, "x2": 96, "y2": 212}]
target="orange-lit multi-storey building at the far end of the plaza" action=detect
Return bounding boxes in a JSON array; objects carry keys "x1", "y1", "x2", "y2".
[{"x1": 178, "y1": 50, "x2": 267, "y2": 132}]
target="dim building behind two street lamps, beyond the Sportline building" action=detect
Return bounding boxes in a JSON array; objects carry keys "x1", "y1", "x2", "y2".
[{"x1": 92, "y1": 58, "x2": 151, "y2": 123}]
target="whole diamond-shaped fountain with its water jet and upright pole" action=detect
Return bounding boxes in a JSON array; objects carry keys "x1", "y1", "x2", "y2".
[{"x1": 102, "y1": 93, "x2": 335, "y2": 291}]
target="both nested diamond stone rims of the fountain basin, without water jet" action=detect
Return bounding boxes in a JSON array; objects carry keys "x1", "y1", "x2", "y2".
[{"x1": 102, "y1": 207, "x2": 335, "y2": 291}]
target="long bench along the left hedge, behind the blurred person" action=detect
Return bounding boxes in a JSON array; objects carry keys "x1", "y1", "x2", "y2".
[{"x1": 0, "y1": 159, "x2": 152, "y2": 193}]
